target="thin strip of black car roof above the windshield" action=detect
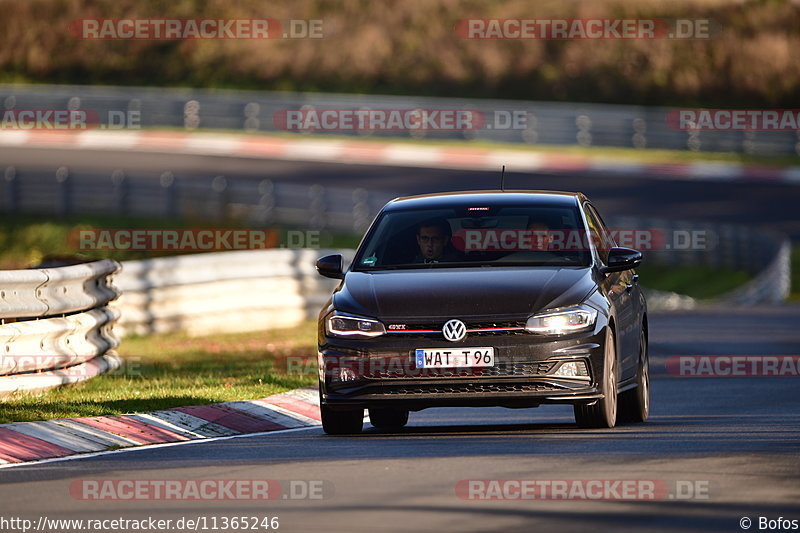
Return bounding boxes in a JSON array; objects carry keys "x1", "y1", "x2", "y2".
[{"x1": 383, "y1": 190, "x2": 586, "y2": 211}]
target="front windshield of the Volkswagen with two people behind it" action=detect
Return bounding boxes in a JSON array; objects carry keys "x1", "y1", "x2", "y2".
[{"x1": 353, "y1": 206, "x2": 591, "y2": 271}]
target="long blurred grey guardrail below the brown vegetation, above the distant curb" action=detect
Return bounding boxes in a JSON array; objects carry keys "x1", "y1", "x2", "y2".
[{"x1": 0, "y1": 84, "x2": 800, "y2": 155}]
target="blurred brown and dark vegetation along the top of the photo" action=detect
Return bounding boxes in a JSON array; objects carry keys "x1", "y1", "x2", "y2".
[{"x1": 0, "y1": 0, "x2": 800, "y2": 107}]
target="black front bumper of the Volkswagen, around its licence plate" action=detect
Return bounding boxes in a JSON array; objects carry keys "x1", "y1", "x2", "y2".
[{"x1": 318, "y1": 325, "x2": 605, "y2": 410}]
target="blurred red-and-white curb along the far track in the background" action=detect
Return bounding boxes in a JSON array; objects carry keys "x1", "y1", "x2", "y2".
[{"x1": 0, "y1": 130, "x2": 800, "y2": 184}]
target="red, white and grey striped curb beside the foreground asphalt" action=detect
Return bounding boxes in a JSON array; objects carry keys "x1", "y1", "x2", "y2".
[{"x1": 0, "y1": 388, "x2": 320, "y2": 467}]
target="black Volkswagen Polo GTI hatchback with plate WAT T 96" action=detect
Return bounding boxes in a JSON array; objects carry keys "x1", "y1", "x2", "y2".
[{"x1": 317, "y1": 191, "x2": 650, "y2": 434}]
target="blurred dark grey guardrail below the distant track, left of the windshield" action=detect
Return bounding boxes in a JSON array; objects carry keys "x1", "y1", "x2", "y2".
[{"x1": 0, "y1": 167, "x2": 390, "y2": 233}]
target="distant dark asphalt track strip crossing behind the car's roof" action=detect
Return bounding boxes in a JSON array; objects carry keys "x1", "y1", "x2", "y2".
[{"x1": 0, "y1": 147, "x2": 800, "y2": 240}]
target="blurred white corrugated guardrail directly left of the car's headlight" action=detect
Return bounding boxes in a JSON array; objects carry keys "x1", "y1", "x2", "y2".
[{"x1": 115, "y1": 249, "x2": 353, "y2": 335}]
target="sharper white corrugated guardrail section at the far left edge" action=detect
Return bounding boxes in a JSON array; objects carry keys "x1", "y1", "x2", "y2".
[{"x1": 0, "y1": 260, "x2": 120, "y2": 397}]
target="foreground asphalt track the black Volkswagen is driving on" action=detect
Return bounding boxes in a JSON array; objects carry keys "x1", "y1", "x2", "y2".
[{"x1": 0, "y1": 306, "x2": 800, "y2": 532}]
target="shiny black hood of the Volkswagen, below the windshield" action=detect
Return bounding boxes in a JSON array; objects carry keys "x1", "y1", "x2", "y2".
[{"x1": 333, "y1": 267, "x2": 596, "y2": 319}]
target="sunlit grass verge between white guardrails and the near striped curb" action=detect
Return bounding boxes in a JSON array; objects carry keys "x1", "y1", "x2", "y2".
[{"x1": 0, "y1": 321, "x2": 317, "y2": 423}]
